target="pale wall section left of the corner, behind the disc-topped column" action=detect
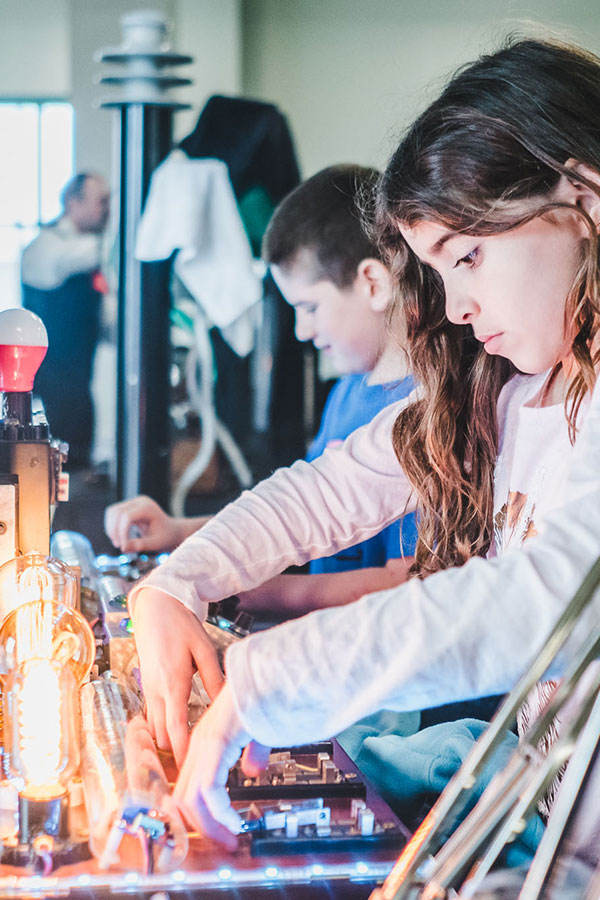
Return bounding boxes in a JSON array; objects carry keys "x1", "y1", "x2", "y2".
[{"x1": 0, "y1": 0, "x2": 241, "y2": 181}]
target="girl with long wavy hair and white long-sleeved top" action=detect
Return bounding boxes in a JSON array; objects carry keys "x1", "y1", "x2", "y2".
[{"x1": 131, "y1": 40, "x2": 600, "y2": 838}]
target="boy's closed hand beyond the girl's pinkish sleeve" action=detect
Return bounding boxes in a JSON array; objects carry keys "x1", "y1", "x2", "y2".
[{"x1": 104, "y1": 496, "x2": 182, "y2": 553}]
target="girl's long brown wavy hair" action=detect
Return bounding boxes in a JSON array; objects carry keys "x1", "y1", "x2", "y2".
[{"x1": 374, "y1": 38, "x2": 600, "y2": 575}]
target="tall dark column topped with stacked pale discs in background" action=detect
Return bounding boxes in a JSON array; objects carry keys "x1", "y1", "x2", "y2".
[{"x1": 98, "y1": 11, "x2": 192, "y2": 507}]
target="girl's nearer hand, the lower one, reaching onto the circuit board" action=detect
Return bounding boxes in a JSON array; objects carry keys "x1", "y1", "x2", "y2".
[{"x1": 174, "y1": 685, "x2": 269, "y2": 848}]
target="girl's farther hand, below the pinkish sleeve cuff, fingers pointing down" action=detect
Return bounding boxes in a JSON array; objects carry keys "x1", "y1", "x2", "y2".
[{"x1": 131, "y1": 587, "x2": 223, "y2": 766}]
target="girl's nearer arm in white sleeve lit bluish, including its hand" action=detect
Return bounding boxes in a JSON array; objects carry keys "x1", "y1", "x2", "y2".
[{"x1": 176, "y1": 378, "x2": 600, "y2": 836}]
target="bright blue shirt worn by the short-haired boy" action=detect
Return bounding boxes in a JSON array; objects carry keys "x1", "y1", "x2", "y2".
[{"x1": 306, "y1": 374, "x2": 417, "y2": 573}]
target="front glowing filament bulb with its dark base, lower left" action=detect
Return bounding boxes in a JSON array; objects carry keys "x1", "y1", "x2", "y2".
[{"x1": 0, "y1": 600, "x2": 96, "y2": 845}]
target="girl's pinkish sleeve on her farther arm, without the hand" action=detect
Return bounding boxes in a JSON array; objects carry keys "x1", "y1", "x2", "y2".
[{"x1": 130, "y1": 398, "x2": 414, "y2": 618}]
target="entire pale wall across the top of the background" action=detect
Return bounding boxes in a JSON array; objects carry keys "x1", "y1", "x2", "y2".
[{"x1": 0, "y1": 0, "x2": 600, "y2": 185}]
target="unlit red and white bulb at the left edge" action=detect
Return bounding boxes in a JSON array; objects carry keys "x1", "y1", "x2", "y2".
[{"x1": 0, "y1": 309, "x2": 48, "y2": 391}]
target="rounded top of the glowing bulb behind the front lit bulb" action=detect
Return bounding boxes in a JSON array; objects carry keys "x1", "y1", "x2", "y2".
[{"x1": 0, "y1": 553, "x2": 77, "y2": 622}]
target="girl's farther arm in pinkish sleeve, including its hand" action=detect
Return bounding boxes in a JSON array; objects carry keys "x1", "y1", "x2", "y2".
[{"x1": 129, "y1": 405, "x2": 411, "y2": 760}]
